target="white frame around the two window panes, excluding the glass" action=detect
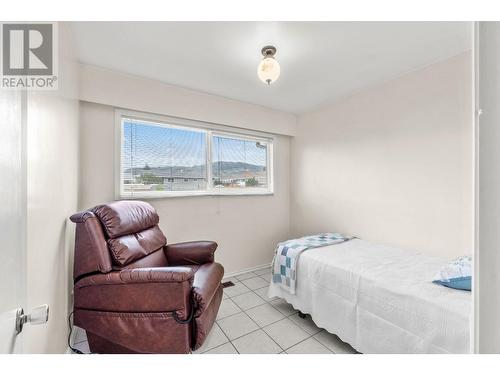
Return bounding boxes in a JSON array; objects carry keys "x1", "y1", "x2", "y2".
[{"x1": 114, "y1": 109, "x2": 275, "y2": 200}]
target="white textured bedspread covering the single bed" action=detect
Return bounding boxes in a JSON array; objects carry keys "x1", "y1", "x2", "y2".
[{"x1": 269, "y1": 239, "x2": 472, "y2": 353}]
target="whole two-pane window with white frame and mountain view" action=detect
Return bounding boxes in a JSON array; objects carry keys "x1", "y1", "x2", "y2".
[{"x1": 116, "y1": 111, "x2": 272, "y2": 198}]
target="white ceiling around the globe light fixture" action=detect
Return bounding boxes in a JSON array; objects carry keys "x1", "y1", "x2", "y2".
[{"x1": 73, "y1": 22, "x2": 471, "y2": 113}]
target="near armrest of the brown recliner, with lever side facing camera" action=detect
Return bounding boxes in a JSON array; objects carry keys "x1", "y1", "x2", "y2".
[{"x1": 74, "y1": 267, "x2": 194, "y2": 319}]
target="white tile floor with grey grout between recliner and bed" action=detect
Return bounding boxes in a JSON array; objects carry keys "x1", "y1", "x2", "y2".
[{"x1": 74, "y1": 268, "x2": 356, "y2": 354}]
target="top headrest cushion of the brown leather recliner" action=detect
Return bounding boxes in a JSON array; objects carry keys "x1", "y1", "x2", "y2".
[{"x1": 92, "y1": 201, "x2": 160, "y2": 238}]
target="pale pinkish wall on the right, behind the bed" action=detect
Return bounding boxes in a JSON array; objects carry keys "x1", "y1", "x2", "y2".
[{"x1": 290, "y1": 52, "x2": 473, "y2": 258}]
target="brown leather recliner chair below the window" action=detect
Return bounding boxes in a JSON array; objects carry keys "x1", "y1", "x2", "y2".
[{"x1": 71, "y1": 201, "x2": 224, "y2": 353}]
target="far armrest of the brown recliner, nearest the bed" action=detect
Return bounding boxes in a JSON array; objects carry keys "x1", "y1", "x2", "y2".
[{"x1": 163, "y1": 241, "x2": 218, "y2": 266}]
